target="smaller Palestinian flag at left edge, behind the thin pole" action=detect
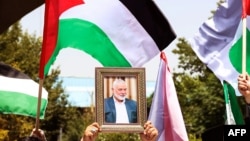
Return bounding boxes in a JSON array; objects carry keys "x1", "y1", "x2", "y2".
[{"x1": 0, "y1": 62, "x2": 48, "y2": 119}]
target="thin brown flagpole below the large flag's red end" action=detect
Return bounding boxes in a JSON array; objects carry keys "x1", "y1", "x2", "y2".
[{"x1": 35, "y1": 79, "x2": 43, "y2": 131}]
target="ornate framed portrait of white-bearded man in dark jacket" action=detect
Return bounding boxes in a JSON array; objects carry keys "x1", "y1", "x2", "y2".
[{"x1": 95, "y1": 67, "x2": 147, "y2": 133}]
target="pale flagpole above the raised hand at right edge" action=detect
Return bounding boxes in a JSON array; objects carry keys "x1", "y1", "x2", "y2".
[{"x1": 242, "y1": 18, "x2": 247, "y2": 74}]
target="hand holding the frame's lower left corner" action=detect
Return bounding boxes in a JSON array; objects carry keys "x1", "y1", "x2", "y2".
[{"x1": 81, "y1": 122, "x2": 101, "y2": 141}]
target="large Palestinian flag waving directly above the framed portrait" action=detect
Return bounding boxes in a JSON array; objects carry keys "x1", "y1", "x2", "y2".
[{"x1": 40, "y1": 0, "x2": 176, "y2": 78}]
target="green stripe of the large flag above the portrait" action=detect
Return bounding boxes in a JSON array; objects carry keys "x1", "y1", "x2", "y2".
[{"x1": 45, "y1": 19, "x2": 131, "y2": 72}]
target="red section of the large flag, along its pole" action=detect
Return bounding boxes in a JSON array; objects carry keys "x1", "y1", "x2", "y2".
[{"x1": 39, "y1": 0, "x2": 83, "y2": 79}]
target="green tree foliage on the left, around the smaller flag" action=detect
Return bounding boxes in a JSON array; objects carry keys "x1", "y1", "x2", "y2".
[{"x1": 0, "y1": 23, "x2": 84, "y2": 141}]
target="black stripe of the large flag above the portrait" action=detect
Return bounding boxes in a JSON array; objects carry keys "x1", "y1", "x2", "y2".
[{"x1": 120, "y1": 0, "x2": 176, "y2": 51}]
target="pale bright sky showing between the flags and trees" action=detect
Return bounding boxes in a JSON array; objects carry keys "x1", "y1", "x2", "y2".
[{"x1": 21, "y1": 0, "x2": 218, "y2": 106}]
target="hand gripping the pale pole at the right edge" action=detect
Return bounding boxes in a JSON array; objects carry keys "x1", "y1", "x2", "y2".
[{"x1": 238, "y1": 74, "x2": 250, "y2": 104}]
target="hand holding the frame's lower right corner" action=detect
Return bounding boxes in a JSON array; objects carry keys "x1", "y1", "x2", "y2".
[{"x1": 140, "y1": 121, "x2": 158, "y2": 141}]
